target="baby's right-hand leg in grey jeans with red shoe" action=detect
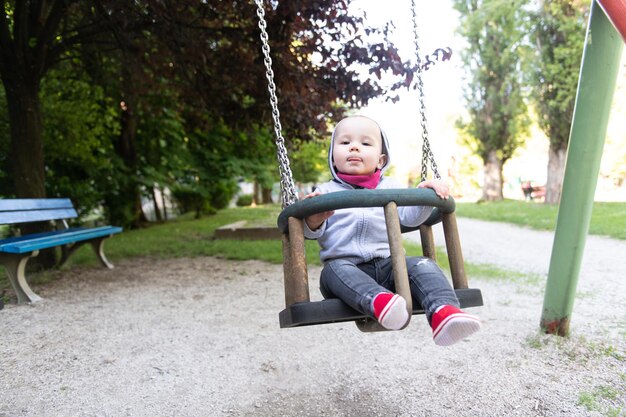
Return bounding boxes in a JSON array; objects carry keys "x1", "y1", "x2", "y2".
[{"x1": 407, "y1": 257, "x2": 480, "y2": 346}]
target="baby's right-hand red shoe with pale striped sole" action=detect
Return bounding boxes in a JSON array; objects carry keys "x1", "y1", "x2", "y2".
[{"x1": 430, "y1": 305, "x2": 480, "y2": 346}]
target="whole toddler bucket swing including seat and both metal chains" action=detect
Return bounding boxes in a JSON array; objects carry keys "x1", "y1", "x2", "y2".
[{"x1": 256, "y1": 0, "x2": 482, "y2": 331}]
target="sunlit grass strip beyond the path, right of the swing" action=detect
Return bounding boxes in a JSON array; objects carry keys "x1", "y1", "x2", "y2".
[{"x1": 456, "y1": 200, "x2": 626, "y2": 239}]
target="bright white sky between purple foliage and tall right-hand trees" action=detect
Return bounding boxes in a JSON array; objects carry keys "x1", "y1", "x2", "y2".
[{"x1": 346, "y1": 0, "x2": 463, "y2": 184}]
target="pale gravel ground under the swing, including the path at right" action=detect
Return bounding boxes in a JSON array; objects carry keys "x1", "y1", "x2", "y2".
[{"x1": 0, "y1": 219, "x2": 626, "y2": 417}]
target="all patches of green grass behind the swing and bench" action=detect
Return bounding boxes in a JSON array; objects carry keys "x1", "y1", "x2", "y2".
[{"x1": 0, "y1": 200, "x2": 626, "y2": 300}]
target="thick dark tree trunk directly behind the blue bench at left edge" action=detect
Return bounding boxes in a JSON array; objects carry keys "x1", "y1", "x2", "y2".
[{"x1": 0, "y1": 0, "x2": 100, "y2": 266}]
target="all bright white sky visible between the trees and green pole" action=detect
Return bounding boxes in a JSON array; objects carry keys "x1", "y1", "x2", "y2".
[{"x1": 352, "y1": 0, "x2": 626, "y2": 201}]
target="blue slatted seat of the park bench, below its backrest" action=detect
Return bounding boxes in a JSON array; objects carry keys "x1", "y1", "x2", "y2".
[{"x1": 0, "y1": 226, "x2": 122, "y2": 253}]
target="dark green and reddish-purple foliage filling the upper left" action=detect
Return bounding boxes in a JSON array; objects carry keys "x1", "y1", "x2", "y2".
[{"x1": 0, "y1": 0, "x2": 411, "y2": 226}]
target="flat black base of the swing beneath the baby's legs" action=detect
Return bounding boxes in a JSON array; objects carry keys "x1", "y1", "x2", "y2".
[{"x1": 278, "y1": 288, "x2": 483, "y2": 328}]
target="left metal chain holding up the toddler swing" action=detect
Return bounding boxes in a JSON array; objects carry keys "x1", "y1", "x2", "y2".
[{"x1": 255, "y1": 0, "x2": 298, "y2": 208}]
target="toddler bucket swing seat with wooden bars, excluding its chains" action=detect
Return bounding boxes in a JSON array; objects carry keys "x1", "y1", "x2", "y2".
[{"x1": 278, "y1": 188, "x2": 483, "y2": 332}]
